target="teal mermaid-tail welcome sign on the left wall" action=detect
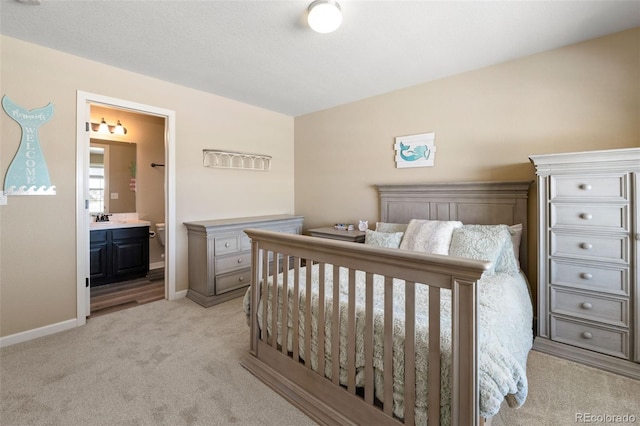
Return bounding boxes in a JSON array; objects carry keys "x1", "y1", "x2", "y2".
[{"x1": 2, "y1": 96, "x2": 56, "y2": 195}]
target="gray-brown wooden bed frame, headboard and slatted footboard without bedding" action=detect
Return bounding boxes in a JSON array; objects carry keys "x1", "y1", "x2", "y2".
[{"x1": 242, "y1": 181, "x2": 531, "y2": 425}]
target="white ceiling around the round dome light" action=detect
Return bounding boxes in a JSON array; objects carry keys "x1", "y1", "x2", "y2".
[{"x1": 0, "y1": 0, "x2": 640, "y2": 116}]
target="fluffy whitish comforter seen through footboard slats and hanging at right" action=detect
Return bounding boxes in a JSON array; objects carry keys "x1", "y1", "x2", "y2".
[{"x1": 245, "y1": 265, "x2": 533, "y2": 424}]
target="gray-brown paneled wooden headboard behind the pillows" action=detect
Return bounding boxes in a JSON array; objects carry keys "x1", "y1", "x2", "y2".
[{"x1": 376, "y1": 181, "x2": 532, "y2": 274}]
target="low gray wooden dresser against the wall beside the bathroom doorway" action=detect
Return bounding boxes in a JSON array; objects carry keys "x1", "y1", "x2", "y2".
[{"x1": 184, "y1": 215, "x2": 304, "y2": 307}]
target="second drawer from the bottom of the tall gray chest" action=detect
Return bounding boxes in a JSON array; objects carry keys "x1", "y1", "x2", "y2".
[{"x1": 551, "y1": 287, "x2": 629, "y2": 327}]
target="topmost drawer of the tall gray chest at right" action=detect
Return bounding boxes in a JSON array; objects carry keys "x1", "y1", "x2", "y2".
[{"x1": 549, "y1": 174, "x2": 628, "y2": 201}]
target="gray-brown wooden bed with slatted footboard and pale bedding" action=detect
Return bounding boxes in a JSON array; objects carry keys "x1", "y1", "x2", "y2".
[{"x1": 243, "y1": 182, "x2": 532, "y2": 425}]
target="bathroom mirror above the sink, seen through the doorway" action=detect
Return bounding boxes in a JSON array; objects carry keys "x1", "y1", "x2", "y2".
[{"x1": 89, "y1": 138, "x2": 137, "y2": 214}]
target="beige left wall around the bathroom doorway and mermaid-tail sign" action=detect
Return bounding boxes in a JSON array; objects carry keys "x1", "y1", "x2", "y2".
[{"x1": 0, "y1": 36, "x2": 294, "y2": 336}]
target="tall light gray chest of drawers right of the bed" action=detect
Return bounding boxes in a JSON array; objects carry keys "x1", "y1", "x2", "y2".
[{"x1": 530, "y1": 148, "x2": 640, "y2": 378}]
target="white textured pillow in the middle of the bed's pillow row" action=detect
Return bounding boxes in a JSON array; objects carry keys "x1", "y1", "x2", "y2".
[{"x1": 400, "y1": 219, "x2": 462, "y2": 255}]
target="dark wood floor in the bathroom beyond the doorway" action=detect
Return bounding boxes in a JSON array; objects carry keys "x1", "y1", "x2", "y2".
[{"x1": 89, "y1": 271, "x2": 164, "y2": 318}]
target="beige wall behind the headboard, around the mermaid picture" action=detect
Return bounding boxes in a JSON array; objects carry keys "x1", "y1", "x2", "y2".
[{"x1": 295, "y1": 28, "x2": 640, "y2": 302}]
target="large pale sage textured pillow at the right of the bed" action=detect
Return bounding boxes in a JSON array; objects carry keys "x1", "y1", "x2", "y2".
[{"x1": 449, "y1": 225, "x2": 519, "y2": 274}]
